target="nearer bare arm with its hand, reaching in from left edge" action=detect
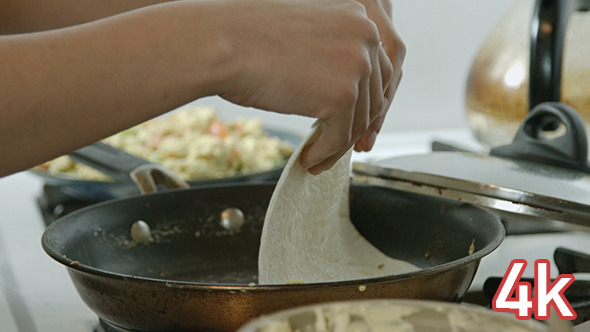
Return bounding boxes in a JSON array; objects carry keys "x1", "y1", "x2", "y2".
[{"x1": 0, "y1": 0, "x2": 402, "y2": 176}]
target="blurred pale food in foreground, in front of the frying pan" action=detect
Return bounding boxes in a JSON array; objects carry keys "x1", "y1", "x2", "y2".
[{"x1": 245, "y1": 301, "x2": 549, "y2": 332}]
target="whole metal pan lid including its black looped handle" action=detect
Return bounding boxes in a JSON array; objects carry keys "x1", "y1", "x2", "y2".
[{"x1": 353, "y1": 103, "x2": 590, "y2": 226}]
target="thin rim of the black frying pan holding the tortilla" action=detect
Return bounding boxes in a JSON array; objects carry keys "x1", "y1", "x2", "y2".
[{"x1": 41, "y1": 181, "x2": 506, "y2": 291}]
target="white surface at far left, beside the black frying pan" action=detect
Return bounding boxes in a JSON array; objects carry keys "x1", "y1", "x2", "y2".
[{"x1": 0, "y1": 172, "x2": 97, "y2": 332}]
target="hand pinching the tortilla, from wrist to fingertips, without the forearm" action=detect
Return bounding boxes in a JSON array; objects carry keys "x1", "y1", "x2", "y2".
[{"x1": 219, "y1": 0, "x2": 403, "y2": 174}]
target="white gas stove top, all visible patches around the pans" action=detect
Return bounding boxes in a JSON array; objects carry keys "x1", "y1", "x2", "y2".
[{"x1": 0, "y1": 128, "x2": 590, "y2": 332}]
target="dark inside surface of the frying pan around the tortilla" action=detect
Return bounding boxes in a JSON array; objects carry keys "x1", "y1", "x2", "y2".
[{"x1": 43, "y1": 184, "x2": 503, "y2": 285}]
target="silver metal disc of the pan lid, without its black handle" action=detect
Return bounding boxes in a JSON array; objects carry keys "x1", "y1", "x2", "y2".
[{"x1": 353, "y1": 151, "x2": 590, "y2": 226}]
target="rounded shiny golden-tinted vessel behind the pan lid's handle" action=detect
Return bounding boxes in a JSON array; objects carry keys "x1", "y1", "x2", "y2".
[{"x1": 465, "y1": 0, "x2": 590, "y2": 147}]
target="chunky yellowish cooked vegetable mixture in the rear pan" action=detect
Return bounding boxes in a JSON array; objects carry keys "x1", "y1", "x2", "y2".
[{"x1": 38, "y1": 106, "x2": 293, "y2": 181}]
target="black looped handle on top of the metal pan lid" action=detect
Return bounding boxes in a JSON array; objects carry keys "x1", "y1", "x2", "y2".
[{"x1": 490, "y1": 102, "x2": 590, "y2": 172}]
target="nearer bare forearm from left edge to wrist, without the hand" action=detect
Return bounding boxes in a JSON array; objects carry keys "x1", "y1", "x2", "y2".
[{"x1": 0, "y1": 1, "x2": 238, "y2": 175}]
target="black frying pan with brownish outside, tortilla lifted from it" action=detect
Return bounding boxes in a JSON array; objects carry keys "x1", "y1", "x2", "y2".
[{"x1": 42, "y1": 183, "x2": 504, "y2": 331}]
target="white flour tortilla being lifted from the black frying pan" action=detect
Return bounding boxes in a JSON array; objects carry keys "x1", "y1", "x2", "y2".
[{"x1": 258, "y1": 125, "x2": 418, "y2": 285}]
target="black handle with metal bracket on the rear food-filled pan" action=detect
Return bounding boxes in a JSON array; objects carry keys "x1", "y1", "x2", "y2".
[{"x1": 69, "y1": 142, "x2": 189, "y2": 194}]
